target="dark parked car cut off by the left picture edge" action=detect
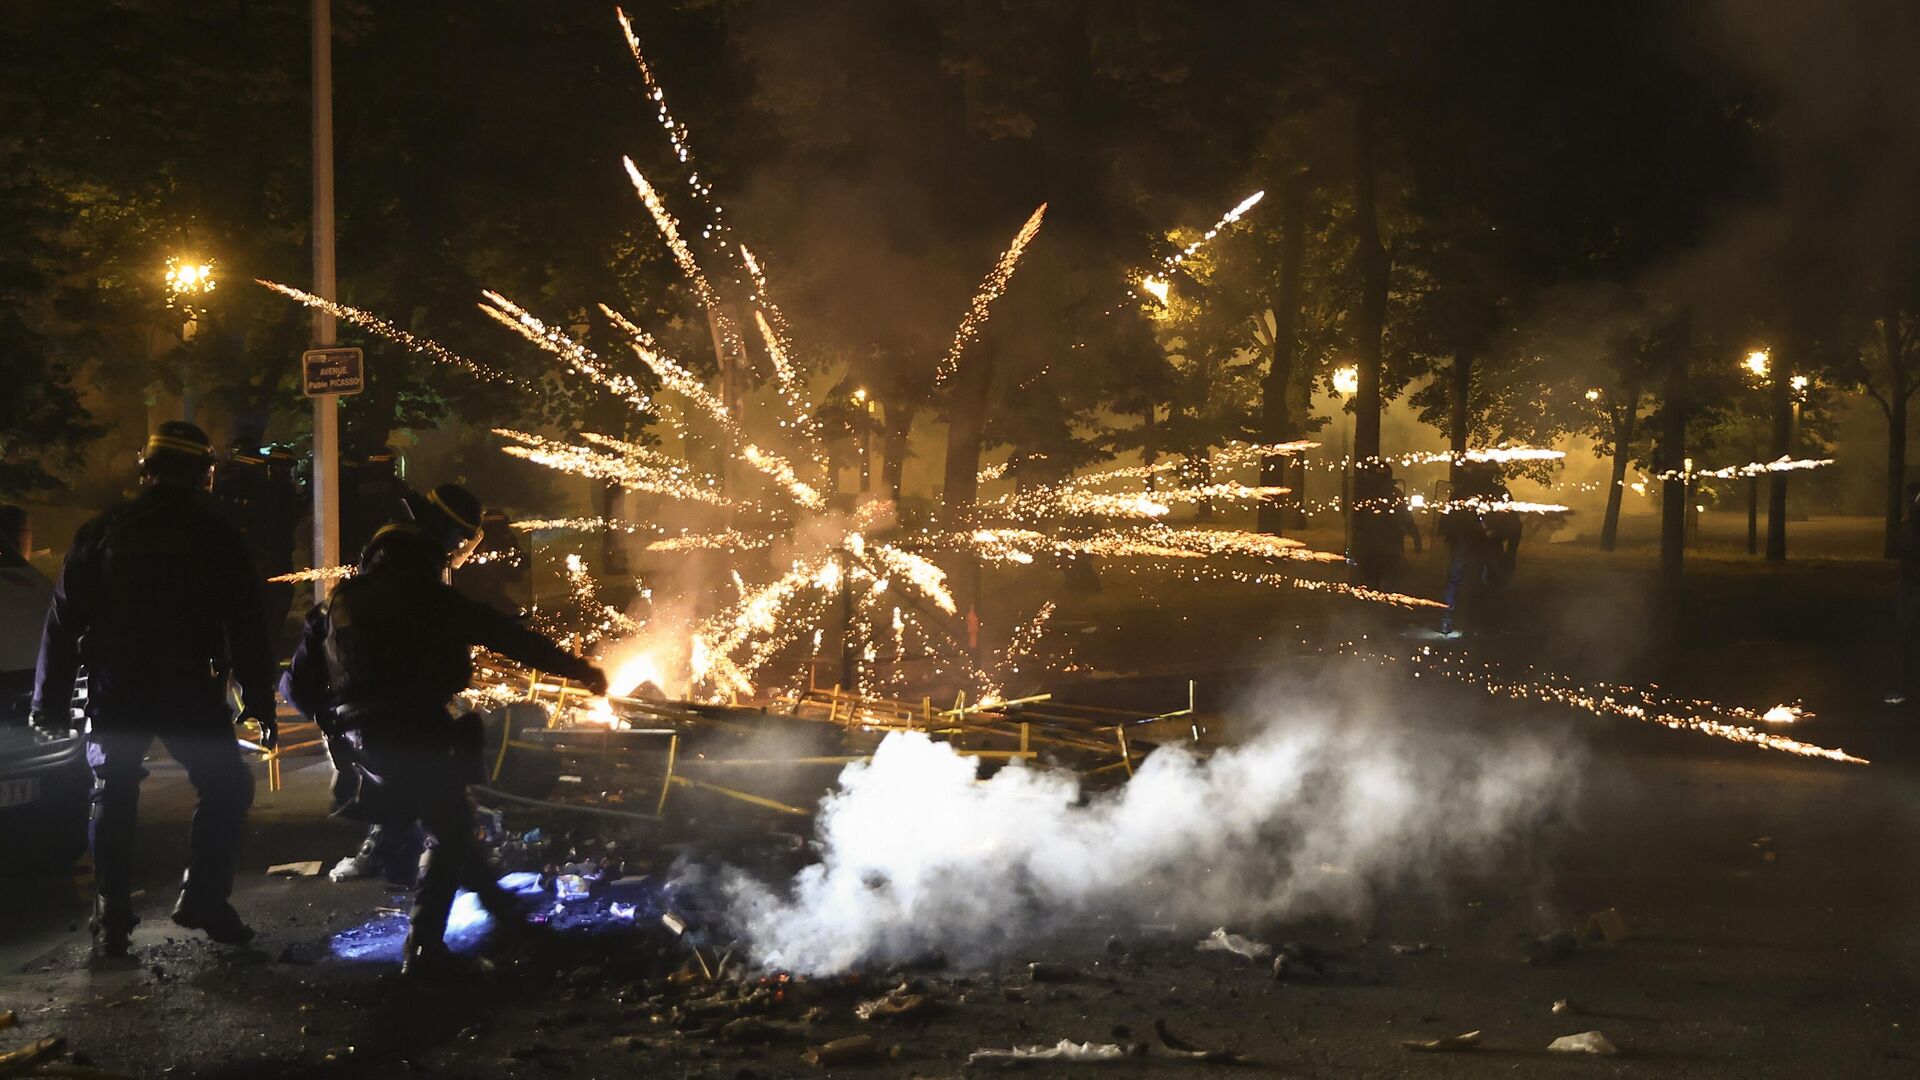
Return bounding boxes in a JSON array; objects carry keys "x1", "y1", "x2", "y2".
[{"x1": 0, "y1": 548, "x2": 92, "y2": 872}]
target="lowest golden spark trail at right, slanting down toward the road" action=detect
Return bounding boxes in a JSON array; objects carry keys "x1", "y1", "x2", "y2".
[{"x1": 1382, "y1": 650, "x2": 1868, "y2": 765}]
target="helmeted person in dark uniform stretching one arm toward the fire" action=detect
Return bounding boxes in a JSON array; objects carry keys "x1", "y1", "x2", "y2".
[{"x1": 284, "y1": 484, "x2": 607, "y2": 976}]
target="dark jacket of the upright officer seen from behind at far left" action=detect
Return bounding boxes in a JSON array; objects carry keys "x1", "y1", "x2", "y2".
[{"x1": 33, "y1": 484, "x2": 275, "y2": 730}]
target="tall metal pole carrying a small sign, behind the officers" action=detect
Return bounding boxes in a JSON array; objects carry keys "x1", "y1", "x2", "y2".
[{"x1": 313, "y1": 0, "x2": 340, "y2": 601}]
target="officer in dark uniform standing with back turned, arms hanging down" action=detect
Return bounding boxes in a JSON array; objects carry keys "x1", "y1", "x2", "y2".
[{"x1": 31, "y1": 421, "x2": 276, "y2": 955}]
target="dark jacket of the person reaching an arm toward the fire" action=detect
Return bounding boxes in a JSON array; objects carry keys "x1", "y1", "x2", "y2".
[{"x1": 280, "y1": 525, "x2": 593, "y2": 732}]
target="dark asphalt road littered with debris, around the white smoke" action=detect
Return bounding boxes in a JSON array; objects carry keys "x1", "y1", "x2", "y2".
[{"x1": 0, "y1": 653, "x2": 1920, "y2": 1078}]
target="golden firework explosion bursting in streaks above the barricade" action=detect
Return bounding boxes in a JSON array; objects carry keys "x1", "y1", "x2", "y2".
[{"x1": 261, "y1": 13, "x2": 1860, "y2": 763}]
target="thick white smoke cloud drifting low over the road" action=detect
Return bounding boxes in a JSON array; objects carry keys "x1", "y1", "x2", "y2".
[{"x1": 724, "y1": 680, "x2": 1574, "y2": 974}]
